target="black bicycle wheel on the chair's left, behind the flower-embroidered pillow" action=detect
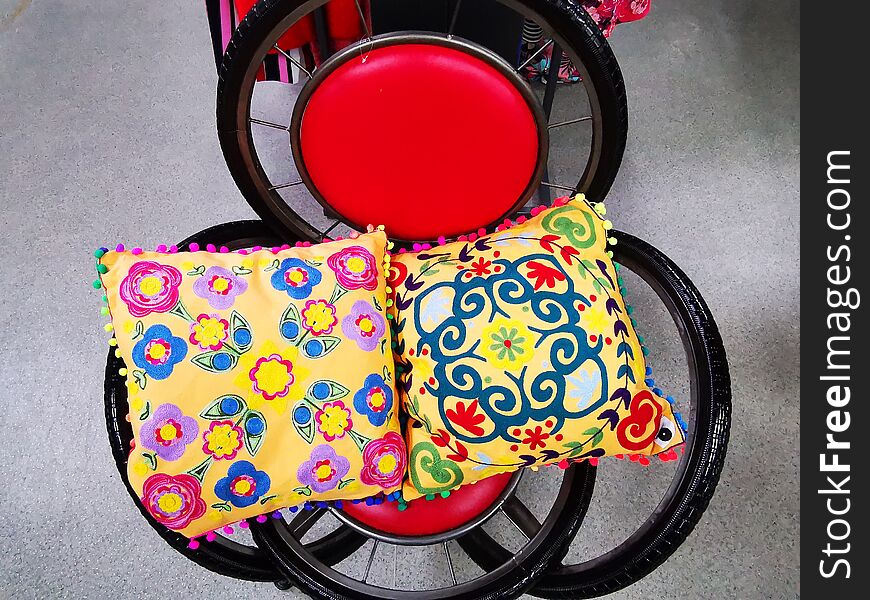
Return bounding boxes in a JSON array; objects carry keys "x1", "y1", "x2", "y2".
[{"x1": 105, "y1": 221, "x2": 366, "y2": 587}]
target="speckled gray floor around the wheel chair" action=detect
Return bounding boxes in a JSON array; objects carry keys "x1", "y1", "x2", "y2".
[{"x1": 0, "y1": 0, "x2": 800, "y2": 600}]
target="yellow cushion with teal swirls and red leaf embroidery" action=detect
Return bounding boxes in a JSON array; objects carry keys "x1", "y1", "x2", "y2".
[{"x1": 389, "y1": 196, "x2": 682, "y2": 500}]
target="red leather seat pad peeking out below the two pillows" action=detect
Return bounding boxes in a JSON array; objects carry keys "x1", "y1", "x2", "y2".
[{"x1": 343, "y1": 473, "x2": 511, "y2": 536}]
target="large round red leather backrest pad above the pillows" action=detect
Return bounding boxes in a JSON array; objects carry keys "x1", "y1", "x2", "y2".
[{"x1": 300, "y1": 43, "x2": 538, "y2": 240}]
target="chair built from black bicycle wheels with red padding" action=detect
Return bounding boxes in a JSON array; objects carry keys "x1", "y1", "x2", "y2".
[{"x1": 106, "y1": 0, "x2": 730, "y2": 599}]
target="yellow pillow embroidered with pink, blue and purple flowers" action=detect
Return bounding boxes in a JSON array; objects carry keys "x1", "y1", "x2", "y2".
[{"x1": 97, "y1": 231, "x2": 406, "y2": 537}]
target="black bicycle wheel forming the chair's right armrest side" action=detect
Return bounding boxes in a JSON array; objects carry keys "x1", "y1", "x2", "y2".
[{"x1": 460, "y1": 232, "x2": 731, "y2": 599}]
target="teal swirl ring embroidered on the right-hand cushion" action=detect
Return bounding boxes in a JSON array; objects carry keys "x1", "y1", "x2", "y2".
[{"x1": 414, "y1": 253, "x2": 608, "y2": 444}]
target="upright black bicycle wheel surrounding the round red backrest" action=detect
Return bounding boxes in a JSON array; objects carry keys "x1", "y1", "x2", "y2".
[{"x1": 217, "y1": 0, "x2": 628, "y2": 240}]
